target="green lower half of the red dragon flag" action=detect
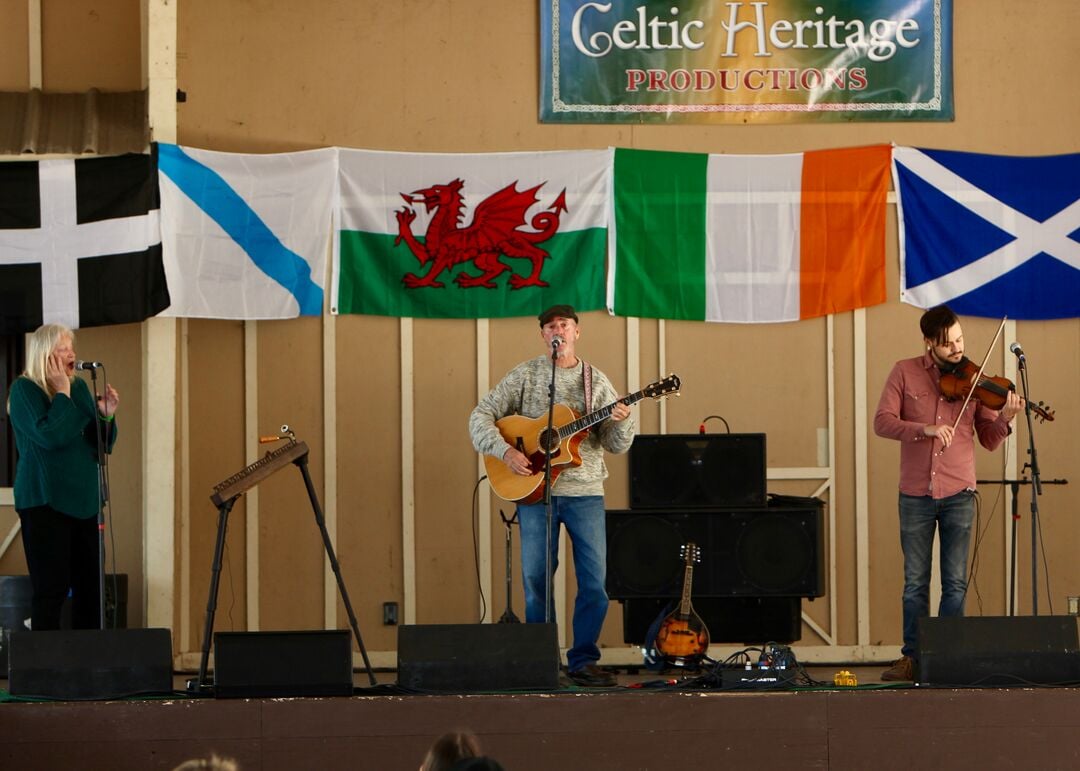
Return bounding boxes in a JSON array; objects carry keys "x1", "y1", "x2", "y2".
[{"x1": 337, "y1": 228, "x2": 607, "y2": 319}]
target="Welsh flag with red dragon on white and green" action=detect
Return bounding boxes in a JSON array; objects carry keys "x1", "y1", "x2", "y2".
[{"x1": 332, "y1": 150, "x2": 611, "y2": 319}]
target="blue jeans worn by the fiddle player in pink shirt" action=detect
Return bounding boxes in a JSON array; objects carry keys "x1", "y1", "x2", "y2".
[{"x1": 900, "y1": 490, "x2": 975, "y2": 659}]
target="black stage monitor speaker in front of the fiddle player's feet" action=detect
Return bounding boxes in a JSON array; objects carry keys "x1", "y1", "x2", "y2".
[{"x1": 917, "y1": 616, "x2": 1080, "y2": 686}]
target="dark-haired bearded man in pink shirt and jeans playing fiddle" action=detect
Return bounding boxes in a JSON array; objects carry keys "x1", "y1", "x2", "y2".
[{"x1": 874, "y1": 306, "x2": 1024, "y2": 680}]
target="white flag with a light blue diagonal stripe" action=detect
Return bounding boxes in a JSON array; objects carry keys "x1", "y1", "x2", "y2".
[{"x1": 160, "y1": 144, "x2": 337, "y2": 320}]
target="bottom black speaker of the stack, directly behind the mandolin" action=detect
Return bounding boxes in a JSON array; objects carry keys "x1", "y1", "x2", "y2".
[{"x1": 621, "y1": 597, "x2": 802, "y2": 645}]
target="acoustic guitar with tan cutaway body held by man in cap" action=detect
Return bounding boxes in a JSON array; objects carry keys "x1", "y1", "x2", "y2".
[{"x1": 484, "y1": 375, "x2": 681, "y2": 503}]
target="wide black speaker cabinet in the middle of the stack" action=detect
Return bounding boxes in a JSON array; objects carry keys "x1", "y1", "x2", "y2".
[{"x1": 607, "y1": 505, "x2": 825, "y2": 599}]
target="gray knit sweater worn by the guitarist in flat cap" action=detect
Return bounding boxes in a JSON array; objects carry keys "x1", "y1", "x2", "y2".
[{"x1": 469, "y1": 355, "x2": 634, "y2": 496}]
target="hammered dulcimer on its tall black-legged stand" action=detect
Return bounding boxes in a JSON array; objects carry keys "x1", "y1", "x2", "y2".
[{"x1": 188, "y1": 436, "x2": 376, "y2": 693}]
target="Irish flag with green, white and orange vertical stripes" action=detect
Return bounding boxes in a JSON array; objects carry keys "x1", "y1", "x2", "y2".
[{"x1": 607, "y1": 145, "x2": 890, "y2": 323}]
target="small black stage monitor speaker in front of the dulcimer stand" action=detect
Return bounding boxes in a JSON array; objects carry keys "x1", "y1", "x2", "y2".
[{"x1": 214, "y1": 630, "x2": 353, "y2": 699}]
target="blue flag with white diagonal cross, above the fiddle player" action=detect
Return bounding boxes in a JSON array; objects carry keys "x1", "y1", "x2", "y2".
[{"x1": 893, "y1": 147, "x2": 1080, "y2": 319}]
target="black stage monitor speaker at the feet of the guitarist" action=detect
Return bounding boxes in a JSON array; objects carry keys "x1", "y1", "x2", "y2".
[{"x1": 397, "y1": 624, "x2": 559, "y2": 692}]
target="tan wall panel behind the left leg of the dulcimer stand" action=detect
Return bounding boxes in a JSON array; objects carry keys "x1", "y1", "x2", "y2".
[{"x1": 185, "y1": 319, "x2": 247, "y2": 634}]
